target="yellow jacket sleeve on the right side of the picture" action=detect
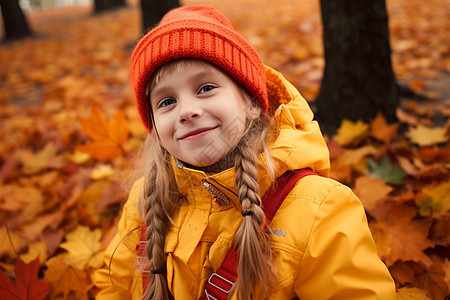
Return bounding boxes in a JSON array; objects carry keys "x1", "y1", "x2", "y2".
[{"x1": 294, "y1": 184, "x2": 397, "y2": 300}]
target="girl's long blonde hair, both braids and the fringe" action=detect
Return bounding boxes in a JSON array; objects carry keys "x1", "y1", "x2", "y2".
[{"x1": 139, "y1": 59, "x2": 276, "y2": 300}]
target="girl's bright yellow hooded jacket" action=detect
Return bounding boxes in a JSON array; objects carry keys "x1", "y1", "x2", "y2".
[{"x1": 93, "y1": 68, "x2": 397, "y2": 300}]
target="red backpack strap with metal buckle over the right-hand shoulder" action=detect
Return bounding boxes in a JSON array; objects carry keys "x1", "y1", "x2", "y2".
[{"x1": 203, "y1": 169, "x2": 318, "y2": 300}]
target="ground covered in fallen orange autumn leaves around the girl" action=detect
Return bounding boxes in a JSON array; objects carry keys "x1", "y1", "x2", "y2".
[{"x1": 0, "y1": 0, "x2": 450, "y2": 300}]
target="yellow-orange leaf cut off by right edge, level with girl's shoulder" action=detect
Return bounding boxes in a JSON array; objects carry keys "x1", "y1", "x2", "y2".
[{"x1": 415, "y1": 182, "x2": 450, "y2": 217}]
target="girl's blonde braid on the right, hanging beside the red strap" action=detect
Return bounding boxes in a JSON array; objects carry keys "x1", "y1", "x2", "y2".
[{"x1": 235, "y1": 121, "x2": 276, "y2": 299}]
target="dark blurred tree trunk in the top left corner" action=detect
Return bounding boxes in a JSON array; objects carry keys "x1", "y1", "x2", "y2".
[{"x1": 0, "y1": 0, "x2": 32, "y2": 40}]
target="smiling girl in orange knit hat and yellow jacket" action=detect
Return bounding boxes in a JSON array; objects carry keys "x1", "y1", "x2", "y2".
[{"x1": 93, "y1": 6, "x2": 396, "y2": 300}]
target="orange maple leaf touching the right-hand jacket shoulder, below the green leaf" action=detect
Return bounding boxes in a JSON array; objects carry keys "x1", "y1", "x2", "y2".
[{"x1": 354, "y1": 175, "x2": 394, "y2": 212}]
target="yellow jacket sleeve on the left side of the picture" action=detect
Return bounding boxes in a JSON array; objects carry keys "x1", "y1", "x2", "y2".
[{"x1": 92, "y1": 181, "x2": 142, "y2": 300}]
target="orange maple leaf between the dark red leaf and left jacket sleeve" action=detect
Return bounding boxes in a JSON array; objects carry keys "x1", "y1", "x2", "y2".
[{"x1": 45, "y1": 253, "x2": 92, "y2": 299}]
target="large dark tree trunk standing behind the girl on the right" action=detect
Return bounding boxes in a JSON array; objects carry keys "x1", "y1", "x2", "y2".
[{"x1": 315, "y1": 0, "x2": 400, "y2": 131}]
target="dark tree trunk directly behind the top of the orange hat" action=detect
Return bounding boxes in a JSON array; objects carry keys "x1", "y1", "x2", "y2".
[{"x1": 141, "y1": 0, "x2": 180, "y2": 33}]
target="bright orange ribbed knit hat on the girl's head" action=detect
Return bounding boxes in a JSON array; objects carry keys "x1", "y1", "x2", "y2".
[{"x1": 130, "y1": 6, "x2": 268, "y2": 131}]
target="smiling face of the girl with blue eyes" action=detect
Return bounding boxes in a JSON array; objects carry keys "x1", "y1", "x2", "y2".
[{"x1": 150, "y1": 61, "x2": 260, "y2": 167}]
